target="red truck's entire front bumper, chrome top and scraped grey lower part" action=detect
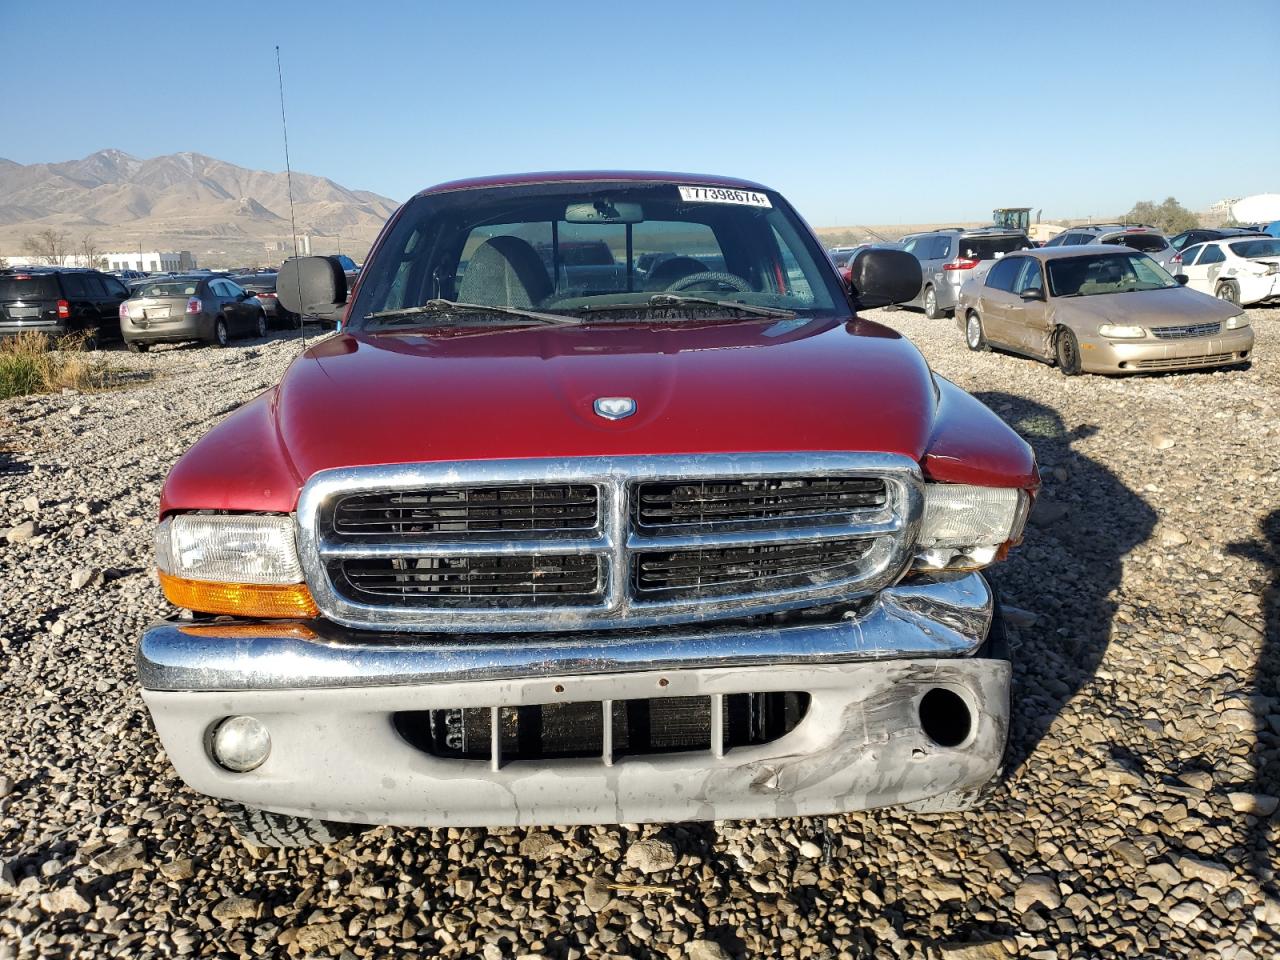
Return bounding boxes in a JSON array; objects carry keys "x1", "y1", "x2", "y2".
[{"x1": 138, "y1": 575, "x2": 1010, "y2": 826}]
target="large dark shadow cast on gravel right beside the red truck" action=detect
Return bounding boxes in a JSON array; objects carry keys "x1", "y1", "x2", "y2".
[{"x1": 974, "y1": 393, "x2": 1156, "y2": 776}]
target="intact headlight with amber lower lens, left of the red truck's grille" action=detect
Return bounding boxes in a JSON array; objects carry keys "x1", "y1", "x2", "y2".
[{"x1": 156, "y1": 513, "x2": 316, "y2": 617}]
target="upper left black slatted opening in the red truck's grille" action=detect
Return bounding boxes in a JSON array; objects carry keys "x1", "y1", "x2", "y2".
[{"x1": 330, "y1": 484, "x2": 599, "y2": 538}]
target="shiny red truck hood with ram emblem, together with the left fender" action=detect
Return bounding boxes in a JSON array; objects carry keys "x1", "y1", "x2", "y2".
[{"x1": 161, "y1": 320, "x2": 1034, "y2": 511}]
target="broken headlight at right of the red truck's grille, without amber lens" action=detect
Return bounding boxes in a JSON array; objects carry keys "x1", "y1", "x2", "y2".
[{"x1": 915, "y1": 484, "x2": 1030, "y2": 570}]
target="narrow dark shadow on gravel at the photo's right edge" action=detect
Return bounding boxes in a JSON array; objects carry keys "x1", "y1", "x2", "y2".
[{"x1": 1228, "y1": 509, "x2": 1280, "y2": 895}]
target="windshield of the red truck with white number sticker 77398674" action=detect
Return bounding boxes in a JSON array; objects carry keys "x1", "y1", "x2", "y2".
[{"x1": 351, "y1": 182, "x2": 847, "y2": 326}]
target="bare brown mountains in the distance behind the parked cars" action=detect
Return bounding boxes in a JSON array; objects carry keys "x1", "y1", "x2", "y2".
[{"x1": 0, "y1": 150, "x2": 398, "y2": 266}]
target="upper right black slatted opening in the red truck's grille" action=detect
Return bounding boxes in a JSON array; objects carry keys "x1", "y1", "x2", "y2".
[{"x1": 635, "y1": 476, "x2": 886, "y2": 527}]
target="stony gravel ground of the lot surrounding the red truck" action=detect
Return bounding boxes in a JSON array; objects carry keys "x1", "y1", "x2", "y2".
[{"x1": 0, "y1": 308, "x2": 1280, "y2": 960}]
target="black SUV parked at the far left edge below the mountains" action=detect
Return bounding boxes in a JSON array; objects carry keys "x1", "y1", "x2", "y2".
[{"x1": 0, "y1": 266, "x2": 129, "y2": 340}]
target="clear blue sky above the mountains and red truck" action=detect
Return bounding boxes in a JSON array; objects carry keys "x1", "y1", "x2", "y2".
[{"x1": 0, "y1": 0, "x2": 1280, "y2": 227}]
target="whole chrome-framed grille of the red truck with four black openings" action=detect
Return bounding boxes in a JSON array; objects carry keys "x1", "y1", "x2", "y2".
[{"x1": 298, "y1": 453, "x2": 922, "y2": 634}]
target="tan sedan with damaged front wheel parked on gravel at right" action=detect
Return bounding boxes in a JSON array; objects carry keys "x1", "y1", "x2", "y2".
[{"x1": 956, "y1": 244, "x2": 1253, "y2": 376}]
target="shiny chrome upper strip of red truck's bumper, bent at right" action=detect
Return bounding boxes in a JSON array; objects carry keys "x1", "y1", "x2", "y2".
[{"x1": 137, "y1": 573, "x2": 995, "y2": 691}]
